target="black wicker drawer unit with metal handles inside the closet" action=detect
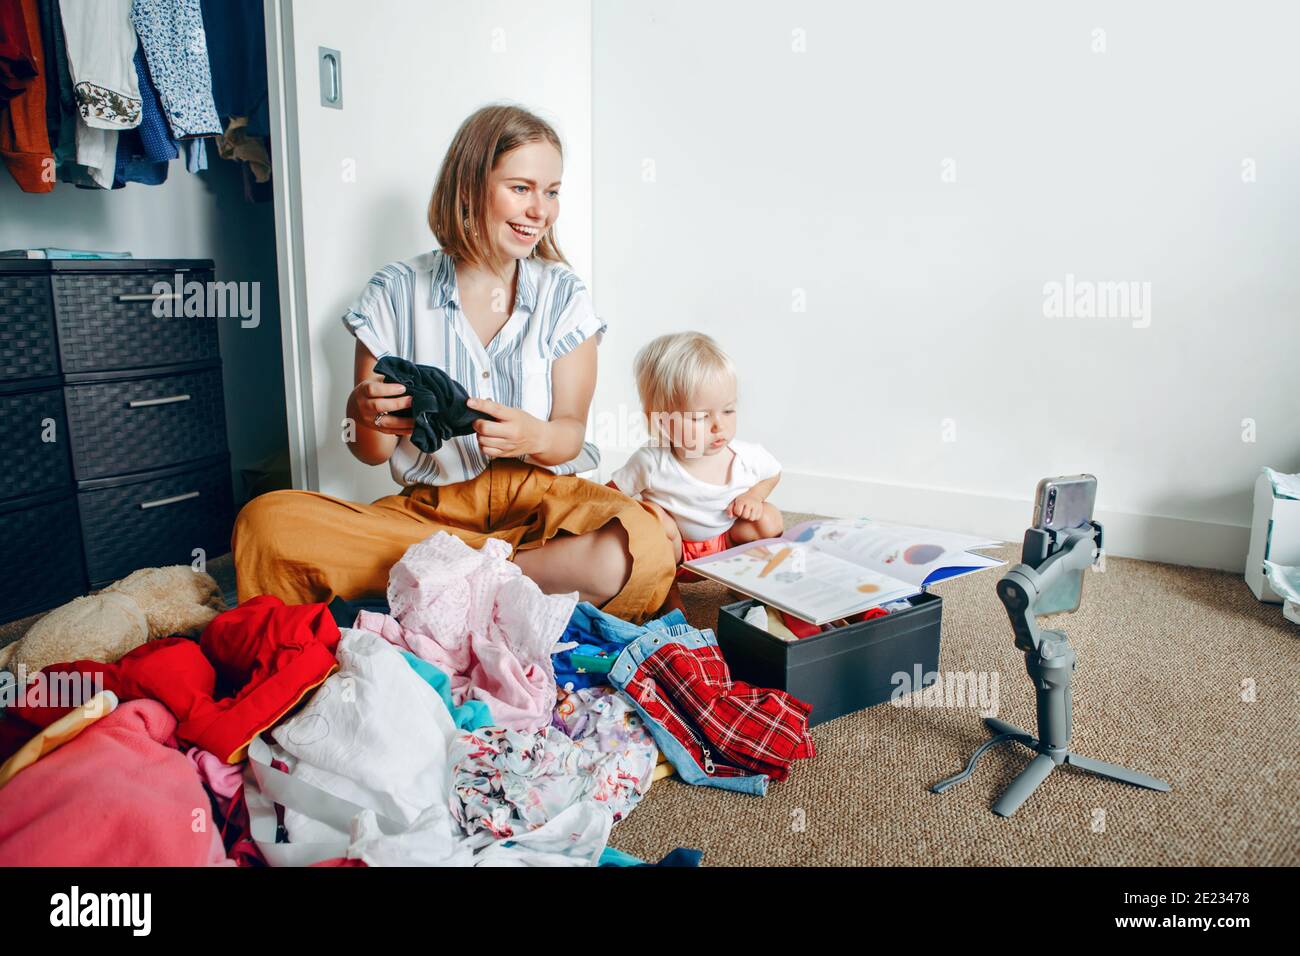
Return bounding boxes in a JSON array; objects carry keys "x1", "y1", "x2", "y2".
[{"x1": 0, "y1": 259, "x2": 234, "y2": 622}]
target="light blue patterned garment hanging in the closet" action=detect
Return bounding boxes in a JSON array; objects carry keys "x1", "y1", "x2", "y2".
[{"x1": 131, "y1": 0, "x2": 221, "y2": 139}]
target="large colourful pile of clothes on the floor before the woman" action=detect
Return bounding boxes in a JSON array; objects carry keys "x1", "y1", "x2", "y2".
[{"x1": 0, "y1": 532, "x2": 814, "y2": 866}]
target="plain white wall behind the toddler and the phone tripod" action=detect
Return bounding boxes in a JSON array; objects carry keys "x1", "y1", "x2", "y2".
[{"x1": 593, "y1": 0, "x2": 1300, "y2": 568}]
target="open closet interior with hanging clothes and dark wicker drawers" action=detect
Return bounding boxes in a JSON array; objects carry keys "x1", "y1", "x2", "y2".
[{"x1": 0, "y1": 0, "x2": 290, "y2": 621}]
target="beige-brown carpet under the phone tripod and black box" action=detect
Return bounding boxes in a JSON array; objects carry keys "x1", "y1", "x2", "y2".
[{"x1": 0, "y1": 515, "x2": 1300, "y2": 866}]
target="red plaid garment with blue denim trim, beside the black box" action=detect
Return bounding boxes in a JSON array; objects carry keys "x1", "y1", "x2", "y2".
[{"x1": 611, "y1": 627, "x2": 815, "y2": 782}]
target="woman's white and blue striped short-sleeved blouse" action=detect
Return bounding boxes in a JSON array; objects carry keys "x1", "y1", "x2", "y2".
[{"x1": 343, "y1": 250, "x2": 606, "y2": 485}]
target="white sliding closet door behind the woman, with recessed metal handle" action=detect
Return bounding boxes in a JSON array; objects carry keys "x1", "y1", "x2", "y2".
[{"x1": 267, "y1": 0, "x2": 592, "y2": 501}]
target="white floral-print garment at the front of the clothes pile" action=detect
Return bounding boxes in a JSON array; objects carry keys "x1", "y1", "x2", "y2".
[{"x1": 450, "y1": 697, "x2": 659, "y2": 839}]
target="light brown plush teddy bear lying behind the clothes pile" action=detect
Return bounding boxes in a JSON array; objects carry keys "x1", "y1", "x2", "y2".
[{"x1": 0, "y1": 564, "x2": 226, "y2": 675}]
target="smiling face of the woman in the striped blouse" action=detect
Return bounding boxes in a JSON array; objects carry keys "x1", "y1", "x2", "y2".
[{"x1": 486, "y1": 140, "x2": 564, "y2": 259}]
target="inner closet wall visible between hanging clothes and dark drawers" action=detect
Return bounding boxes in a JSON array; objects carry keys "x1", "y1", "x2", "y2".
[{"x1": 0, "y1": 162, "x2": 285, "y2": 509}]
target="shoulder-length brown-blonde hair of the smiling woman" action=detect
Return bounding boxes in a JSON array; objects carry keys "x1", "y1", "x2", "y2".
[{"x1": 429, "y1": 104, "x2": 568, "y2": 265}]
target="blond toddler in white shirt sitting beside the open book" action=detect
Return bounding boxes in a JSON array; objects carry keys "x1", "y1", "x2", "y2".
[{"x1": 610, "y1": 332, "x2": 784, "y2": 567}]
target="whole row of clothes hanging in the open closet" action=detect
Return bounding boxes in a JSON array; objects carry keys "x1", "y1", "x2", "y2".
[{"x1": 18, "y1": 0, "x2": 272, "y2": 191}]
